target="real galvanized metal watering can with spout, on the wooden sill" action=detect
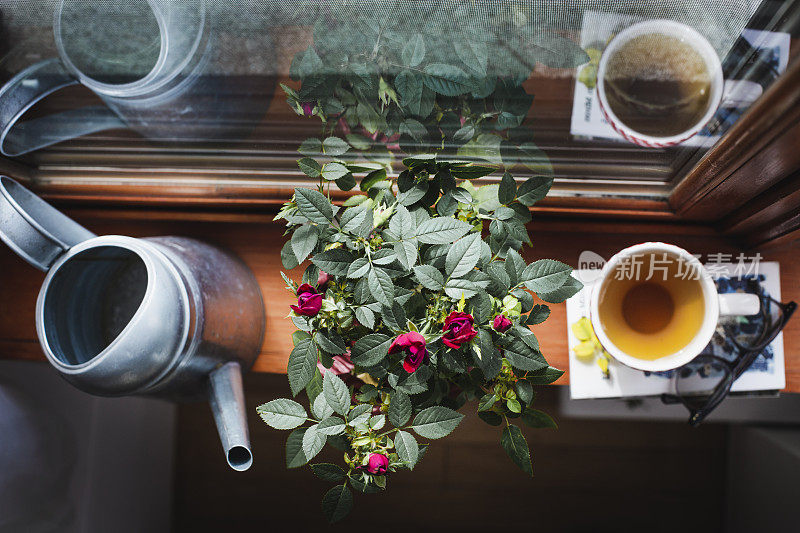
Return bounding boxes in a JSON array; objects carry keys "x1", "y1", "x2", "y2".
[{"x1": 0, "y1": 176, "x2": 265, "y2": 470}]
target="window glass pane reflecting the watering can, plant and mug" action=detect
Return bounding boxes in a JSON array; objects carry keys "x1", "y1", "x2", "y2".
[{"x1": 0, "y1": 0, "x2": 799, "y2": 198}]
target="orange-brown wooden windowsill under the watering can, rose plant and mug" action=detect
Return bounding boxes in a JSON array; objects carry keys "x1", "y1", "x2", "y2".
[{"x1": 0, "y1": 209, "x2": 800, "y2": 392}]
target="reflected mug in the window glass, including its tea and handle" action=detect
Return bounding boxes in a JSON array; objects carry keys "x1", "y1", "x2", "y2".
[{"x1": 597, "y1": 20, "x2": 761, "y2": 147}]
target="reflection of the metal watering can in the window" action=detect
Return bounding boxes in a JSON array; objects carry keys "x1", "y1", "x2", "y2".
[{"x1": 0, "y1": 0, "x2": 209, "y2": 156}]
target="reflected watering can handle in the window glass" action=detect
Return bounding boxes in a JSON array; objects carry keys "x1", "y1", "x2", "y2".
[{"x1": 0, "y1": 57, "x2": 125, "y2": 157}]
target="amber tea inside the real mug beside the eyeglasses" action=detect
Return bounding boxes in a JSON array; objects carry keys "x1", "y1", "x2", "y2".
[{"x1": 598, "y1": 253, "x2": 705, "y2": 360}]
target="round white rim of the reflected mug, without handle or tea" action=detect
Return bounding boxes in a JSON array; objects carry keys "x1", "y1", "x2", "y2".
[{"x1": 597, "y1": 19, "x2": 725, "y2": 146}]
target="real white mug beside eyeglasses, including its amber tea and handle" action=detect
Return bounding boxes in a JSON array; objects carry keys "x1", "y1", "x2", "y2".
[{"x1": 590, "y1": 242, "x2": 760, "y2": 372}]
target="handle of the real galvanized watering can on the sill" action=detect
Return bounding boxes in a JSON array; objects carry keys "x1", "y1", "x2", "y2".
[{"x1": 0, "y1": 176, "x2": 96, "y2": 271}]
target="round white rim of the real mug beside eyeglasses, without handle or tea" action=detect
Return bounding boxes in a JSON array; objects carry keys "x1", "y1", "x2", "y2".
[{"x1": 589, "y1": 242, "x2": 719, "y2": 372}]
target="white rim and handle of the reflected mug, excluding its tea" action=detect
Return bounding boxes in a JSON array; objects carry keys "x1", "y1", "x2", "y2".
[{"x1": 597, "y1": 20, "x2": 761, "y2": 148}]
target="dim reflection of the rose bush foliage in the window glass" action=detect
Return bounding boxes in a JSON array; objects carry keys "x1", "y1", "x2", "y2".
[{"x1": 283, "y1": 0, "x2": 589, "y2": 166}]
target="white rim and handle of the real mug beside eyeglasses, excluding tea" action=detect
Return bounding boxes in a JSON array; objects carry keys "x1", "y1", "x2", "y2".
[{"x1": 589, "y1": 242, "x2": 760, "y2": 372}]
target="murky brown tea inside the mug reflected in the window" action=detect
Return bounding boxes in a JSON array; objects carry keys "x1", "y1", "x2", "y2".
[{"x1": 604, "y1": 33, "x2": 711, "y2": 137}]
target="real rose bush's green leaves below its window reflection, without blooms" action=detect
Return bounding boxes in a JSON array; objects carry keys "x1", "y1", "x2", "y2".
[{"x1": 258, "y1": 149, "x2": 581, "y2": 521}]
